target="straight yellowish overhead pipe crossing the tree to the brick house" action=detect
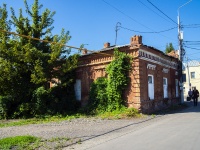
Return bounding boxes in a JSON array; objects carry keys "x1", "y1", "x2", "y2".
[{"x1": 0, "y1": 29, "x2": 113, "y2": 56}]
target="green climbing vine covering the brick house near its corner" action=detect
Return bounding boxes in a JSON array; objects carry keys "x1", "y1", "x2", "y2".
[{"x1": 89, "y1": 49, "x2": 131, "y2": 113}]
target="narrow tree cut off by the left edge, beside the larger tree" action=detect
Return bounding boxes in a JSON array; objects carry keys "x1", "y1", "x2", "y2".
[{"x1": 0, "y1": 4, "x2": 17, "y2": 95}]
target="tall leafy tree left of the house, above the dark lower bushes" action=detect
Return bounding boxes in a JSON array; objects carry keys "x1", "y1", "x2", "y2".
[{"x1": 0, "y1": 0, "x2": 77, "y2": 118}]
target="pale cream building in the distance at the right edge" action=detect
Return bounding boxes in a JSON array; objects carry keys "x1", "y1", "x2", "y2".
[{"x1": 183, "y1": 60, "x2": 200, "y2": 99}]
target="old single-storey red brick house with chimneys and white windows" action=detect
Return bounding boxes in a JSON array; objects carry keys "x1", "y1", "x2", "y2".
[{"x1": 75, "y1": 36, "x2": 179, "y2": 113}]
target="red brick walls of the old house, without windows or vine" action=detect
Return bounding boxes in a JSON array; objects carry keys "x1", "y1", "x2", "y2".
[{"x1": 76, "y1": 42, "x2": 178, "y2": 113}]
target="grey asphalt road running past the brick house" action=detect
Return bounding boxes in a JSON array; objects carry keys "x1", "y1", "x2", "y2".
[{"x1": 86, "y1": 102, "x2": 200, "y2": 150}]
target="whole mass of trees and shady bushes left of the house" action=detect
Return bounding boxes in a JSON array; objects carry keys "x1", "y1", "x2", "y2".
[{"x1": 0, "y1": 0, "x2": 79, "y2": 119}]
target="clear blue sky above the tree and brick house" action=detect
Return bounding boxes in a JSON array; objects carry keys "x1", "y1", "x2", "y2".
[{"x1": 0, "y1": 0, "x2": 200, "y2": 60}]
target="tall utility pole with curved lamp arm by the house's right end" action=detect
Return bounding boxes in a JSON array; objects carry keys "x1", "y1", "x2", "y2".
[{"x1": 177, "y1": 0, "x2": 192, "y2": 103}]
